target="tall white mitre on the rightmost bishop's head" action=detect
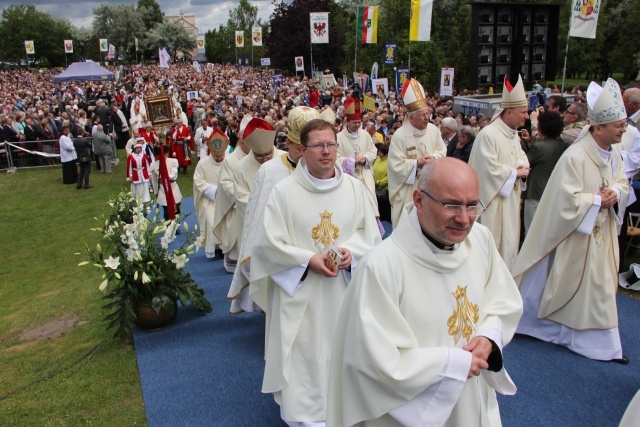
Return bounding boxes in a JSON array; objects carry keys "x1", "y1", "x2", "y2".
[{"x1": 587, "y1": 78, "x2": 627, "y2": 125}]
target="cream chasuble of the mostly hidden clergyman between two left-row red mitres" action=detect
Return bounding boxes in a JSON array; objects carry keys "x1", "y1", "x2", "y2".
[{"x1": 213, "y1": 147, "x2": 246, "y2": 259}]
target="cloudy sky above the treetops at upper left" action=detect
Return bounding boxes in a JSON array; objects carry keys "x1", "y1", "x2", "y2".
[{"x1": 0, "y1": 0, "x2": 274, "y2": 33}]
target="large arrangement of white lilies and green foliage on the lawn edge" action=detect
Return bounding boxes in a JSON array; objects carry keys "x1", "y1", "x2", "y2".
[{"x1": 78, "y1": 192, "x2": 212, "y2": 339}]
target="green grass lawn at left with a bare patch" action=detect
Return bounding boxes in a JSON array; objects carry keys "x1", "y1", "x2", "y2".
[{"x1": 0, "y1": 151, "x2": 195, "y2": 426}]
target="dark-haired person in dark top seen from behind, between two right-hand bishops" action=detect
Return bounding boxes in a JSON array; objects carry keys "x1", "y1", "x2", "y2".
[{"x1": 524, "y1": 110, "x2": 567, "y2": 232}]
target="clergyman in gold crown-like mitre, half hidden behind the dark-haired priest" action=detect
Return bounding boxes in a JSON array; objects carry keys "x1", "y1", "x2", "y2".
[{"x1": 227, "y1": 107, "x2": 322, "y2": 314}]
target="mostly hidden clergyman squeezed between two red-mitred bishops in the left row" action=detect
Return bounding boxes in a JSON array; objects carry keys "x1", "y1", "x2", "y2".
[{"x1": 213, "y1": 114, "x2": 252, "y2": 273}]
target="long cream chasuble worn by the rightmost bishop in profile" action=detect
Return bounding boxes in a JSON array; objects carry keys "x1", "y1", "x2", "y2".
[{"x1": 512, "y1": 133, "x2": 629, "y2": 359}]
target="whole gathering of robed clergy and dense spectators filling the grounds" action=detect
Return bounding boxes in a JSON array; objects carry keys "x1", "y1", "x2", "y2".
[{"x1": 0, "y1": 61, "x2": 640, "y2": 426}]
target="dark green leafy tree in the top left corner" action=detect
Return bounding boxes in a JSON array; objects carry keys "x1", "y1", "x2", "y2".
[{"x1": 0, "y1": 5, "x2": 71, "y2": 66}]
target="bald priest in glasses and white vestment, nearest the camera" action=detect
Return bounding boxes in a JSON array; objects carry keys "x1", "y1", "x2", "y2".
[{"x1": 327, "y1": 157, "x2": 522, "y2": 427}]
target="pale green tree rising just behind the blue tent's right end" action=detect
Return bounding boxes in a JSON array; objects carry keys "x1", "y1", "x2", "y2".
[{"x1": 92, "y1": 3, "x2": 145, "y2": 61}]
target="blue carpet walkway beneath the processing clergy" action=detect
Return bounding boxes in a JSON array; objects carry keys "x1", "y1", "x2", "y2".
[{"x1": 134, "y1": 198, "x2": 640, "y2": 427}]
